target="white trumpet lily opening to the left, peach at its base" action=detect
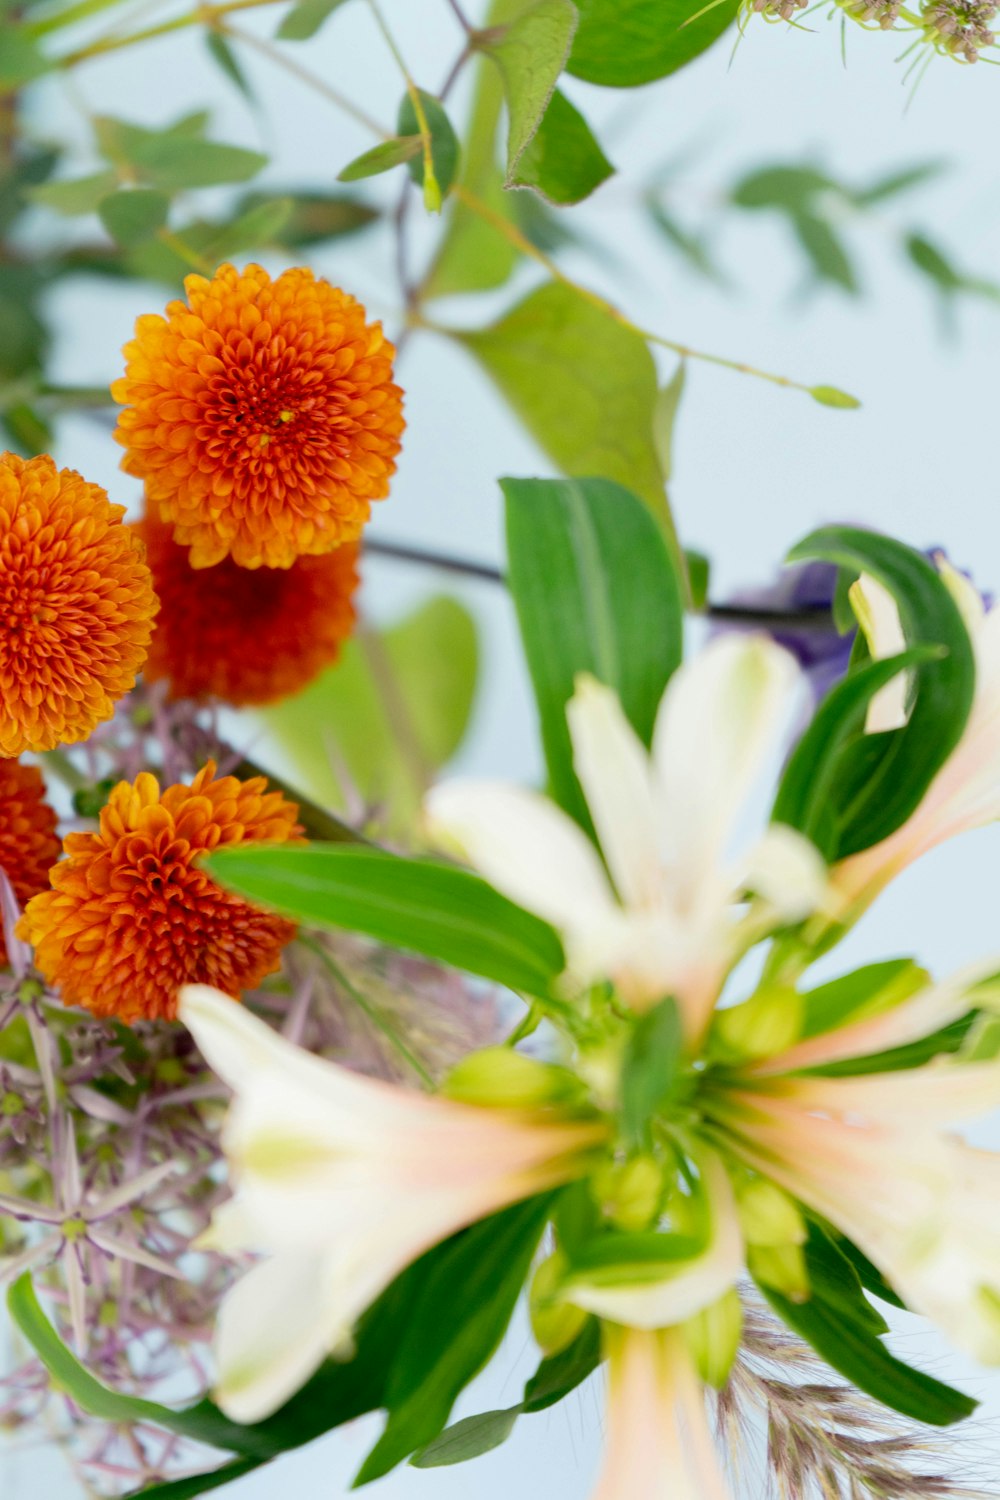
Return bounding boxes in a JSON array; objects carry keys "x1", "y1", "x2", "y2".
[{"x1": 178, "y1": 984, "x2": 604, "y2": 1422}]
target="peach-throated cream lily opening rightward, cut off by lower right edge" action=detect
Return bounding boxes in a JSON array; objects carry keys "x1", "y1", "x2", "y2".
[{"x1": 717, "y1": 965, "x2": 1000, "y2": 1364}]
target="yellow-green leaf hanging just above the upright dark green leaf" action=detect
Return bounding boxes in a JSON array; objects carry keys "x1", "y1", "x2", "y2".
[{"x1": 464, "y1": 282, "x2": 666, "y2": 518}]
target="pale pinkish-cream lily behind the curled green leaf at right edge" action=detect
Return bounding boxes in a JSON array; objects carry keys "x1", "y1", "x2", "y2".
[{"x1": 832, "y1": 563, "x2": 1000, "y2": 908}]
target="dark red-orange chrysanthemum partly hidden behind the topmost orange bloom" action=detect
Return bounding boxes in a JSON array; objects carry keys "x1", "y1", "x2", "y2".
[{"x1": 136, "y1": 510, "x2": 358, "y2": 707}]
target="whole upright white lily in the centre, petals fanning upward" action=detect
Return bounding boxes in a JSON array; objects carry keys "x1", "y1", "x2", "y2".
[{"x1": 427, "y1": 636, "x2": 826, "y2": 1038}]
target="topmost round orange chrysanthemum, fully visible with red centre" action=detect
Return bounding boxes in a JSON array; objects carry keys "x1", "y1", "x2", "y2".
[{"x1": 111, "y1": 266, "x2": 403, "y2": 567}]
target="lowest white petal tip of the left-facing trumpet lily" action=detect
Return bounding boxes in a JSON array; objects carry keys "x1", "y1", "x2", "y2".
[{"x1": 214, "y1": 1253, "x2": 338, "y2": 1422}]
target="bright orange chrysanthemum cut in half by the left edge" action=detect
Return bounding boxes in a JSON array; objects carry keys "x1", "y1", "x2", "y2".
[{"x1": 0, "y1": 453, "x2": 156, "y2": 756}]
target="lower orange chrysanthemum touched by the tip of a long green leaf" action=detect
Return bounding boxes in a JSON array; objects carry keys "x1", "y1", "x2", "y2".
[{"x1": 18, "y1": 764, "x2": 301, "y2": 1022}]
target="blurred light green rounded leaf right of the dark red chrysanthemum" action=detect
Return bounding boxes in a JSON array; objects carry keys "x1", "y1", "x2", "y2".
[{"x1": 255, "y1": 596, "x2": 478, "y2": 830}]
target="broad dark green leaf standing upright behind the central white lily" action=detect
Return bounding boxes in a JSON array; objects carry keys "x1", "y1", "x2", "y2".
[{"x1": 501, "y1": 479, "x2": 684, "y2": 830}]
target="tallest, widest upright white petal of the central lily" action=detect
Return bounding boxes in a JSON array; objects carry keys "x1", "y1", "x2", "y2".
[{"x1": 652, "y1": 636, "x2": 799, "y2": 909}]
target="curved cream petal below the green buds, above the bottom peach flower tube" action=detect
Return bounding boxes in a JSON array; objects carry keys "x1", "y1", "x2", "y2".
[{"x1": 565, "y1": 1155, "x2": 744, "y2": 1329}]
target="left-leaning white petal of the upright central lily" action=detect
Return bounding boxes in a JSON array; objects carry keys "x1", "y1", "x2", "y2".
[{"x1": 424, "y1": 782, "x2": 619, "y2": 932}]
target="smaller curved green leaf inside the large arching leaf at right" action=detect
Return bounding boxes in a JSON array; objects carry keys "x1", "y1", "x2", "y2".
[{"x1": 771, "y1": 648, "x2": 936, "y2": 861}]
